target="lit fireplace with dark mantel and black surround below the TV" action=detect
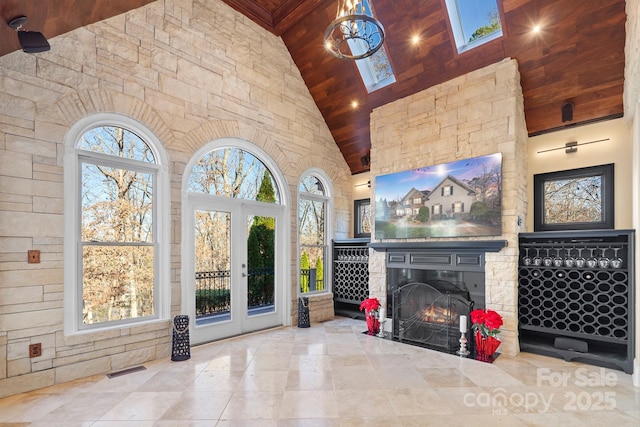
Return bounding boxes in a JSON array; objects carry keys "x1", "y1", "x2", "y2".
[{"x1": 370, "y1": 240, "x2": 506, "y2": 354}]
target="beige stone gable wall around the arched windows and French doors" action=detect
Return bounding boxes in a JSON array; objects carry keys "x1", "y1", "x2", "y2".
[{"x1": 0, "y1": 0, "x2": 351, "y2": 397}]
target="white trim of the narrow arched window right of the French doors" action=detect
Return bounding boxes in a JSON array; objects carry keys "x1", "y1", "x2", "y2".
[{"x1": 296, "y1": 167, "x2": 333, "y2": 296}]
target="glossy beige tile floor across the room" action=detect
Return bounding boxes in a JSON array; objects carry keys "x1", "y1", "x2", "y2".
[{"x1": 0, "y1": 317, "x2": 640, "y2": 427}]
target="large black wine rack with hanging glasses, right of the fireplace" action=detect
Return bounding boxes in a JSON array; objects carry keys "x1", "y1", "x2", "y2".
[{"x1": 518, "y1": 230, "x2": 635, "y2": 373}]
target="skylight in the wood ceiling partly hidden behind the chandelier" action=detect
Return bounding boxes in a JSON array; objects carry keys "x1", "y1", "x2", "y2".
[{"x1": 349, "y1": 0, "x2": 396, "y2": 93}]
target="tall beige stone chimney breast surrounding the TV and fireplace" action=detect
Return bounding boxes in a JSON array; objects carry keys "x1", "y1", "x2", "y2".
[{"x1": 369, "y1": 59, "x2": 527, "y2": 354}]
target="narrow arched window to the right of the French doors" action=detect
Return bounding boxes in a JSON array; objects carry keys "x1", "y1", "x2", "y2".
[{"x1": 298, "y1": 171, "x2": 331, "y2": 294}]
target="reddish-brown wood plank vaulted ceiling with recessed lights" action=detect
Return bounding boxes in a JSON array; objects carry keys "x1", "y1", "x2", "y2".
[{"x1": 0, "y1": 0, "x2": 626, "y2": 174}]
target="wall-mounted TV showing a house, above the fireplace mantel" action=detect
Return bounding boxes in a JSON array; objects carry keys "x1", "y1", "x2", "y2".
[{"x1": 375, "y1": 153, "x2": 502, "y2": 239}]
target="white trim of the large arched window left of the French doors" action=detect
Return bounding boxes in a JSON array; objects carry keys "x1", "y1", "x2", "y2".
[{"x1": 63, "y1": 113, "x2": 171, "y2": 336}]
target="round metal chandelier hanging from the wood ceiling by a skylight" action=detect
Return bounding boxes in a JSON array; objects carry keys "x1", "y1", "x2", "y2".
[{"x1": 324, "y1": 0, "x2": 384, "y2": 59}]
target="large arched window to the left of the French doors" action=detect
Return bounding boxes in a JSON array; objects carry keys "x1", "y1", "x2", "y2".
[{"x1": 65, "y1": 114, "x2": 168, "y2": 333}]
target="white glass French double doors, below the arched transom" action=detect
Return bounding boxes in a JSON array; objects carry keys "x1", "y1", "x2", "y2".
[{"x1": 185, "y1": 195, "x2": 284, "y2": 344}]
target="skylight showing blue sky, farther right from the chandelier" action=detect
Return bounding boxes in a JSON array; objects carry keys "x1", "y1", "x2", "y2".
[{"x1": 445, "y1": 0, "x2": 502, "y2": 53}]
